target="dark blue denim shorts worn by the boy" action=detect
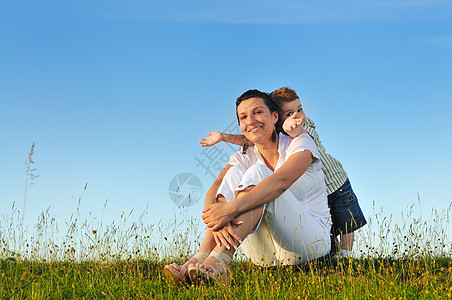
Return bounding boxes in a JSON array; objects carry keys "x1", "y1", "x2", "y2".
[{"x1": 328, "y1": 179, "x2": 367, "y2": 236}]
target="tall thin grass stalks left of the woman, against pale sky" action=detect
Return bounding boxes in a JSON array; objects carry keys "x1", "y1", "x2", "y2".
[{"x1": 0, "y1": 180, "x2": 205, "y2": 263}]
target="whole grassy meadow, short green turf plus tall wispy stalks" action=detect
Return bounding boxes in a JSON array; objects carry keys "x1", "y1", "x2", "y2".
[{"x1": 0, "y1": 195, "x2": 452, "y2": 299}]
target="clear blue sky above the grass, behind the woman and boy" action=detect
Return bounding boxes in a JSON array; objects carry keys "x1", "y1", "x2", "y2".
[{"x1": 0, "y1": 0, "x2": 452, "y2": 241}]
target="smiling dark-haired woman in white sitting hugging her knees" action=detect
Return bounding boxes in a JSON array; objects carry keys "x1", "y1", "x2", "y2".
[{"x1": 165, "y1": 90, "x2": 331, "y2": 285}]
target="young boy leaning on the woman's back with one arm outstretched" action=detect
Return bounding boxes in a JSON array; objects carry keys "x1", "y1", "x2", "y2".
[{"x1": 201, "y1": 87, "x2": 367, "y2": 257}]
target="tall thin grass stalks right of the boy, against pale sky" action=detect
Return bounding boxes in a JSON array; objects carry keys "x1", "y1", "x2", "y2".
[{"x1": 354, "y1": 197, "x2": 452, "y2": 259}]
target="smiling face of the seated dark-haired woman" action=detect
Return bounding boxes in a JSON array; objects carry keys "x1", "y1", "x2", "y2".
[{"x1": 237, "y1": 98, "x2": 278, "y2": 144}]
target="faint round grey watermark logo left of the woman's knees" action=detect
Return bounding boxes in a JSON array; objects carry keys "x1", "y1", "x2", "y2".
[{"x1": 168, "y1": 173, "x2": 203, "y2": 207}]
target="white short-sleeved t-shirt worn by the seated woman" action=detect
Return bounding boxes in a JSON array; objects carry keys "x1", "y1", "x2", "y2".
[{"x1": 228, "y1": 133, "x2": 330, "y2": 221}]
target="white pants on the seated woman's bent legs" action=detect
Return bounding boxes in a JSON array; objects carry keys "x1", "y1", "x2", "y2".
[{"x1": 217, "y1": 164, "x2": 331, "y2": 266}]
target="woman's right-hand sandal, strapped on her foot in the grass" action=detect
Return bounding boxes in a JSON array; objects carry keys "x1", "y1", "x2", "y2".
[{"x1": 188, "y1": 251, "x2": 231, "y2": 286}]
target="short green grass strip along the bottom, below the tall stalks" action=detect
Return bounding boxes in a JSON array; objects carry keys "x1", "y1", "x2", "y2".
[{"x1": 0, "y1": 257, "x2": 452, "y2": 299}]
